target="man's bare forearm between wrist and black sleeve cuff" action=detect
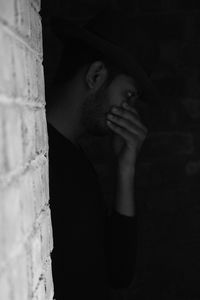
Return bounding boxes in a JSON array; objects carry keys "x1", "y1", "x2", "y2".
[{"x1": 114, "y1": 170, "x2": 136, "y2": 217}]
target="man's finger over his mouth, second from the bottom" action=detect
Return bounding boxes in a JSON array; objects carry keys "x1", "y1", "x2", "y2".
[{"x1": 107, "y1": 114, "x2": 147, "y2": 135}]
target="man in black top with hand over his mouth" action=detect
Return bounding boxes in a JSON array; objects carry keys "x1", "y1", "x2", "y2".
[{"x1": 47, "y1": 12, "x2": 158, "y2": 300}]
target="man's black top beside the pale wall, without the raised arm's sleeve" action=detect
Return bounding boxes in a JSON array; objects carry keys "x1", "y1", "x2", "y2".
[{"x1": 49, "y1": 123, "x2": 109, "y2": 300}]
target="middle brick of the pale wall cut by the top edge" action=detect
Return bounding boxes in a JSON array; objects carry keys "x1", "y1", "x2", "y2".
[{"x1": 16, "y1": 0, "x2": 31, "y2": 37}]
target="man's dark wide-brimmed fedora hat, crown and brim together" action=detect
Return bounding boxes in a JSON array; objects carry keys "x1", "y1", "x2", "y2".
[{"x1": 51, "y1": 10, "x2": 159, "y2": 104}]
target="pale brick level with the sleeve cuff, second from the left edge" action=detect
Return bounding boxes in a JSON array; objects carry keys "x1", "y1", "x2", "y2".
[{"x1": 20, "y1": 170, "x2": 35, "y2": 235}]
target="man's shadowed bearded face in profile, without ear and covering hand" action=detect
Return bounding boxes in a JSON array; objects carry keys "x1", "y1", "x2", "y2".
[{"x1": 82, "y1": 74, "x2": 138, "y2": 136}]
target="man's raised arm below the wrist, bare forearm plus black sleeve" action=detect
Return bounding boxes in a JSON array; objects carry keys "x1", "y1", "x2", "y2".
[{"x1": 107, "y1": 172, "x2": 137, "y2": 289}]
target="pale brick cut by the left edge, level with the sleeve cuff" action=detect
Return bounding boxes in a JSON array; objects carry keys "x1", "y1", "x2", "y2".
[{"x1": 0, "y1": 182, "x2": 22, "y2": 263}]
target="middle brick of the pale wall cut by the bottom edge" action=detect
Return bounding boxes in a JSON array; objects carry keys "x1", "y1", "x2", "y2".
[{"x1": 9, "y1": 249, "x2": 29, "y2": 300}]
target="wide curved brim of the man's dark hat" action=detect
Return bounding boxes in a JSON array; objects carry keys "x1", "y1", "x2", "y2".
[{"x1": 51, "y1": 18, "x2": 159, "y2": 104}]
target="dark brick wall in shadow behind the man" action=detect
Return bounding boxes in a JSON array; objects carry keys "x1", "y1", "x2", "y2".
[{"x1": 41, "y1": 0, "x2": 200, "y2": 300}]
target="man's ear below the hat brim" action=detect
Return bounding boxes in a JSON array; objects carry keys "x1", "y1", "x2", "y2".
[{"x1": 86, "y1": 61, "x2": 108, "y2": 91}]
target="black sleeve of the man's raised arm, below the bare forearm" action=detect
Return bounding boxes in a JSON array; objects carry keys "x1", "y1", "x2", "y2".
[{"x1": 105, "y1": 210, "x2": 137, "y2": 289}]
